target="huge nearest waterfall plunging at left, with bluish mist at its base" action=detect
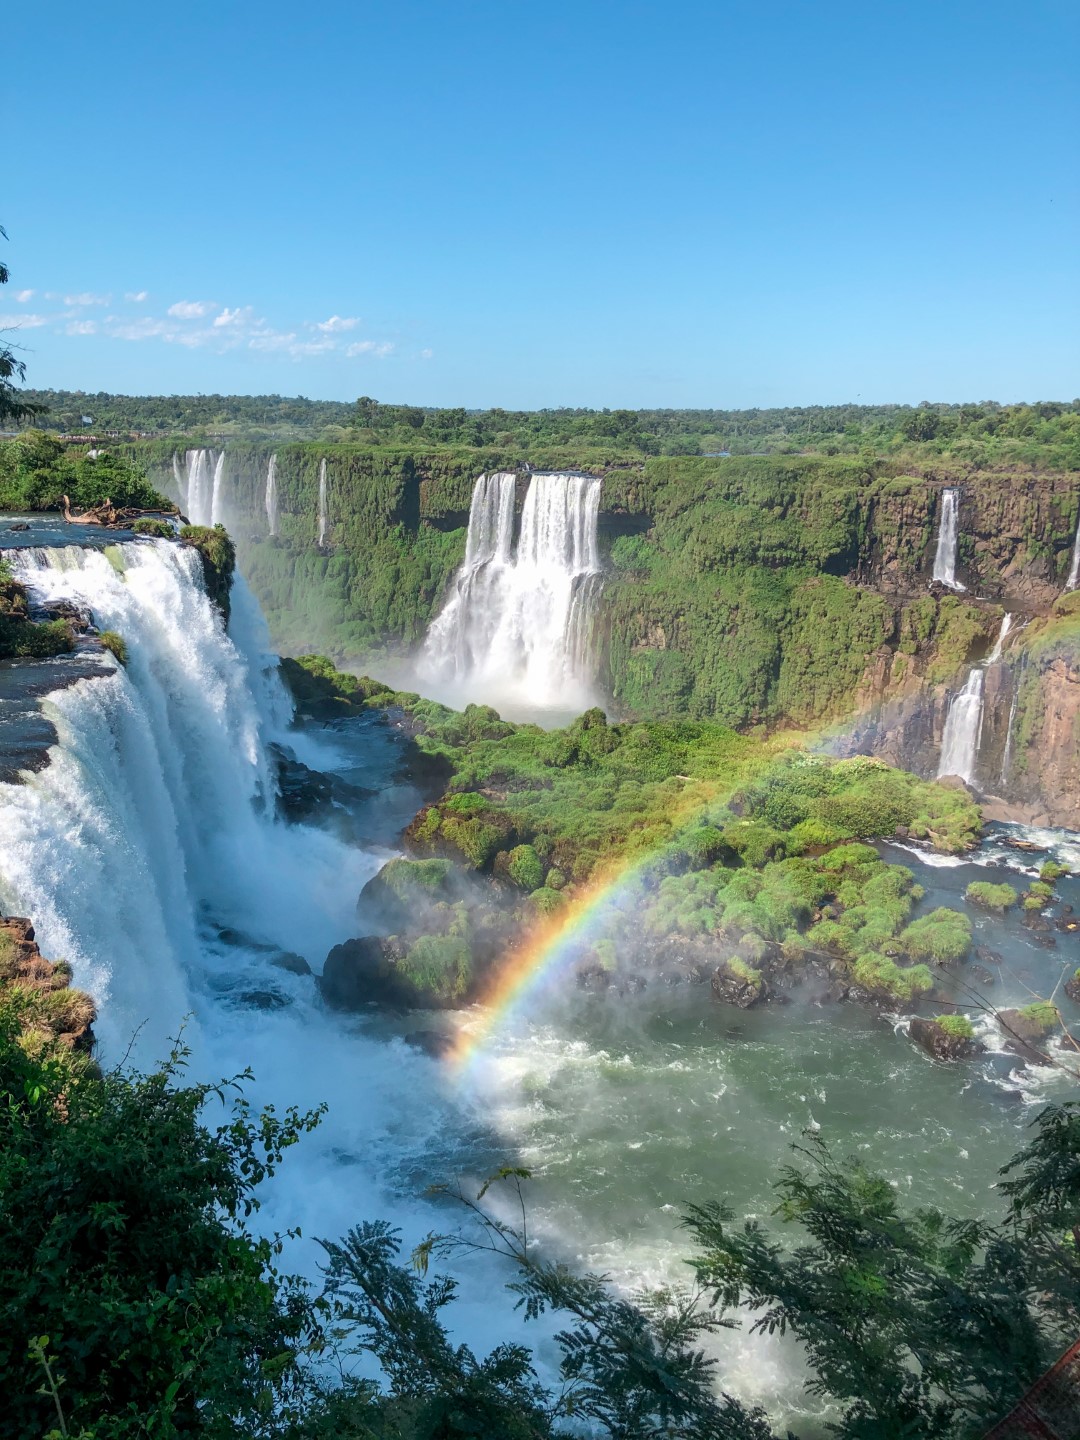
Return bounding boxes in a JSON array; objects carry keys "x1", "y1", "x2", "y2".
[{"x1": 0, "y1": 540, "x2": 373, "y2": 1057}]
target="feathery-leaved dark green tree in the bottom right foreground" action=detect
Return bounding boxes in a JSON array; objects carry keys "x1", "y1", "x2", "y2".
[{"x1": 687, "y1": 1103, "x2": 1080, "y2": 1440}]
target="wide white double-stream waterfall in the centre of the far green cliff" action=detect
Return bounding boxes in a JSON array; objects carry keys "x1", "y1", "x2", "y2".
[{"x1": 419, "y1": 472, "x2": 600, "y2": 711}]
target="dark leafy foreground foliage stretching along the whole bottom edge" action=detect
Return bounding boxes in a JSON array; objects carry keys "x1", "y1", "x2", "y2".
[{"x1": 0, "y1": 984, "x2": 1080, "y2": 1440}]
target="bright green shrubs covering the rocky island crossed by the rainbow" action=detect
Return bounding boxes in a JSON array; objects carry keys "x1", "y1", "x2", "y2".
[{"x1": 285, "y1": 657, "x2": 979, "y2": 1004}]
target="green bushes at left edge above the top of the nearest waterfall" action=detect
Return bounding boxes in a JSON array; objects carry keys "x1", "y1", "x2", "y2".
[{"x1": 0, "y1": 431, "x2": 171, "y2": 510}]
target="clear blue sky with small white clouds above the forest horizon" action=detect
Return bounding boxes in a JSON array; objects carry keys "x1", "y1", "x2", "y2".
[{"x1": 0, "y1": 0, "x2": 1080, "y2": 408}]
